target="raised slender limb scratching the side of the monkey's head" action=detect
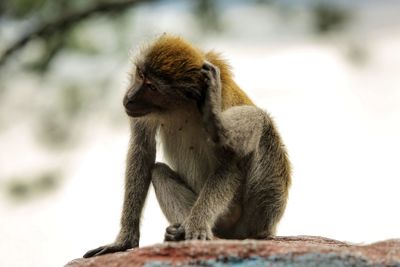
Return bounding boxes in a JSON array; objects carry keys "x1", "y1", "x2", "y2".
[{"x1": 200, "y1": 61, "x2": 224, "y2": 146}]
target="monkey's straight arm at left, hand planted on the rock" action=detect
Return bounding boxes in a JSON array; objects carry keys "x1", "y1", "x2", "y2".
[{"x1": 83, "y1": 119, "x2": 156, "y2": 258}]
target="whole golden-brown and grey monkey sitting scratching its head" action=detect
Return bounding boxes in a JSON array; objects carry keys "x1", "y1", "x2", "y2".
[{"x1": 84, "y1": 34, "x2": 291, "y2": 258}]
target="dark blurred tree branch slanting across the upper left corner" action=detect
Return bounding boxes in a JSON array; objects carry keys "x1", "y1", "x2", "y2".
[{"x1": 0, "y1": 0, "x2": 151, "y2": 66}]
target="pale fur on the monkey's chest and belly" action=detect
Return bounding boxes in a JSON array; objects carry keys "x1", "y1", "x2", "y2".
[{"x1": 159, "y1": 112, "x2": 216, "y2": 193}]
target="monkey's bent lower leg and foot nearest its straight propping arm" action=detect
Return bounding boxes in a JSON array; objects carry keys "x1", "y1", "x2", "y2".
[{"x1": 152, "y1": 163, "x2": 197, "y2": 241}]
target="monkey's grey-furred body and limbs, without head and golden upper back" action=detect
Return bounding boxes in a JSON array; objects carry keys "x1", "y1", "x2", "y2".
[{"x1": 85, "y1": 63, "x2": 290, "y2": 257}]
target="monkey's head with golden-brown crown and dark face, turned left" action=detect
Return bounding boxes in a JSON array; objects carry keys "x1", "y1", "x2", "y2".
[{"x1": 123, "y1": 34, "x2": 204, "y2": 117}]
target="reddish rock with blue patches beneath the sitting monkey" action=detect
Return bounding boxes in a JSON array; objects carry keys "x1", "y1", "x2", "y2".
[{"x1": 66, "y1": 236, "x2": 400, "y2": 267}]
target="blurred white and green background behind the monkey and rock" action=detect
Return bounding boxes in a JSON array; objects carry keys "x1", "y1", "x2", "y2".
[{"x1": 0, "y1": 0, "x2": 400, "y2": 267}]
